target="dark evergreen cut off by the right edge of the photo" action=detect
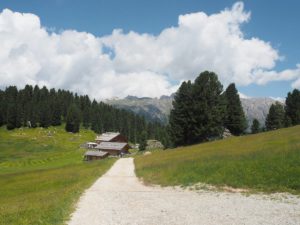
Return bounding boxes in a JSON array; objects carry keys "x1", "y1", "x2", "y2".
[{"x1": 285, "y1": 89, "x2": 300, "y2": 125}]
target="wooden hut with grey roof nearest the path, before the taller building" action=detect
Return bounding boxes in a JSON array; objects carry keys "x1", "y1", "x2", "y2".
[{"x1": 95, "y1": 142, "x2": 129, "y2": 155}]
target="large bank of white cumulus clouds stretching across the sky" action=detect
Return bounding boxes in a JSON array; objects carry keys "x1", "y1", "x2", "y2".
[{"x1": 0, "y1": 2, "x2": 300, "y2": 99}]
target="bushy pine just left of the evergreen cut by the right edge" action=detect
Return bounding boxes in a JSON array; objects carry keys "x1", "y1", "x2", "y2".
[{"x1": 266, "y1": 102, "x2": 285, "y2": 130}]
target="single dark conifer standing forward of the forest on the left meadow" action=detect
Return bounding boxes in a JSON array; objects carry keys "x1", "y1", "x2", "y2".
[{"x1": 65, "y1": 104, "x2": 80, "y2": 133}]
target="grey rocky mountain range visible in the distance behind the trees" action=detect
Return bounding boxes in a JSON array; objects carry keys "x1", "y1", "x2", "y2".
[{"x1": 105, "y1": 94, "x2": 282, "y2": 127}]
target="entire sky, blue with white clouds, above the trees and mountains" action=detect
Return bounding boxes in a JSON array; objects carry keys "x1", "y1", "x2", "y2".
[{"x1": 0, "y1": 0, "x2": 300, "y2": 99}]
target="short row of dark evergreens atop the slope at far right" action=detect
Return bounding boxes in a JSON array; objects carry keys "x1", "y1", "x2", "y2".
[{"x1": 251, "y1": 89, "x2": 300, "y2": 133}]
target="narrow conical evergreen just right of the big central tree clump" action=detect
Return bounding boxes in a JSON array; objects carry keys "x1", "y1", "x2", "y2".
[{"x1": 225, "y1": 83, "x2": 247, "y2": 135}]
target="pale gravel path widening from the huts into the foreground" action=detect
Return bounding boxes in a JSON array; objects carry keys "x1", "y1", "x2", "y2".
[{"x1": 68, "y1": 158, "x2": 300, "y2": 225}]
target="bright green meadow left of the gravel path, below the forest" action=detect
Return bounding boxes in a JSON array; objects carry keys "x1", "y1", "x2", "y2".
[{"x1": 0, "y1": 127, "x2": 115, "y2": 225}]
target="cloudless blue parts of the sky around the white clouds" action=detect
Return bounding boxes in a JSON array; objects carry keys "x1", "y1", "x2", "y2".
[{"x1": 0, "y1": 0, "x2": 300, "y2": 97}]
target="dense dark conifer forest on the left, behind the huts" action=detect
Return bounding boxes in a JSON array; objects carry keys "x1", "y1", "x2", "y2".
[{"x1": 0, "y1": 85, "x2": 167, "y2": 145}]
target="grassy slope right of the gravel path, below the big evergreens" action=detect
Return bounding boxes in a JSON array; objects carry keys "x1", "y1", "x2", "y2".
[{"x1": 135, "y1": 126, "x2": 300, "y2": 194}]
